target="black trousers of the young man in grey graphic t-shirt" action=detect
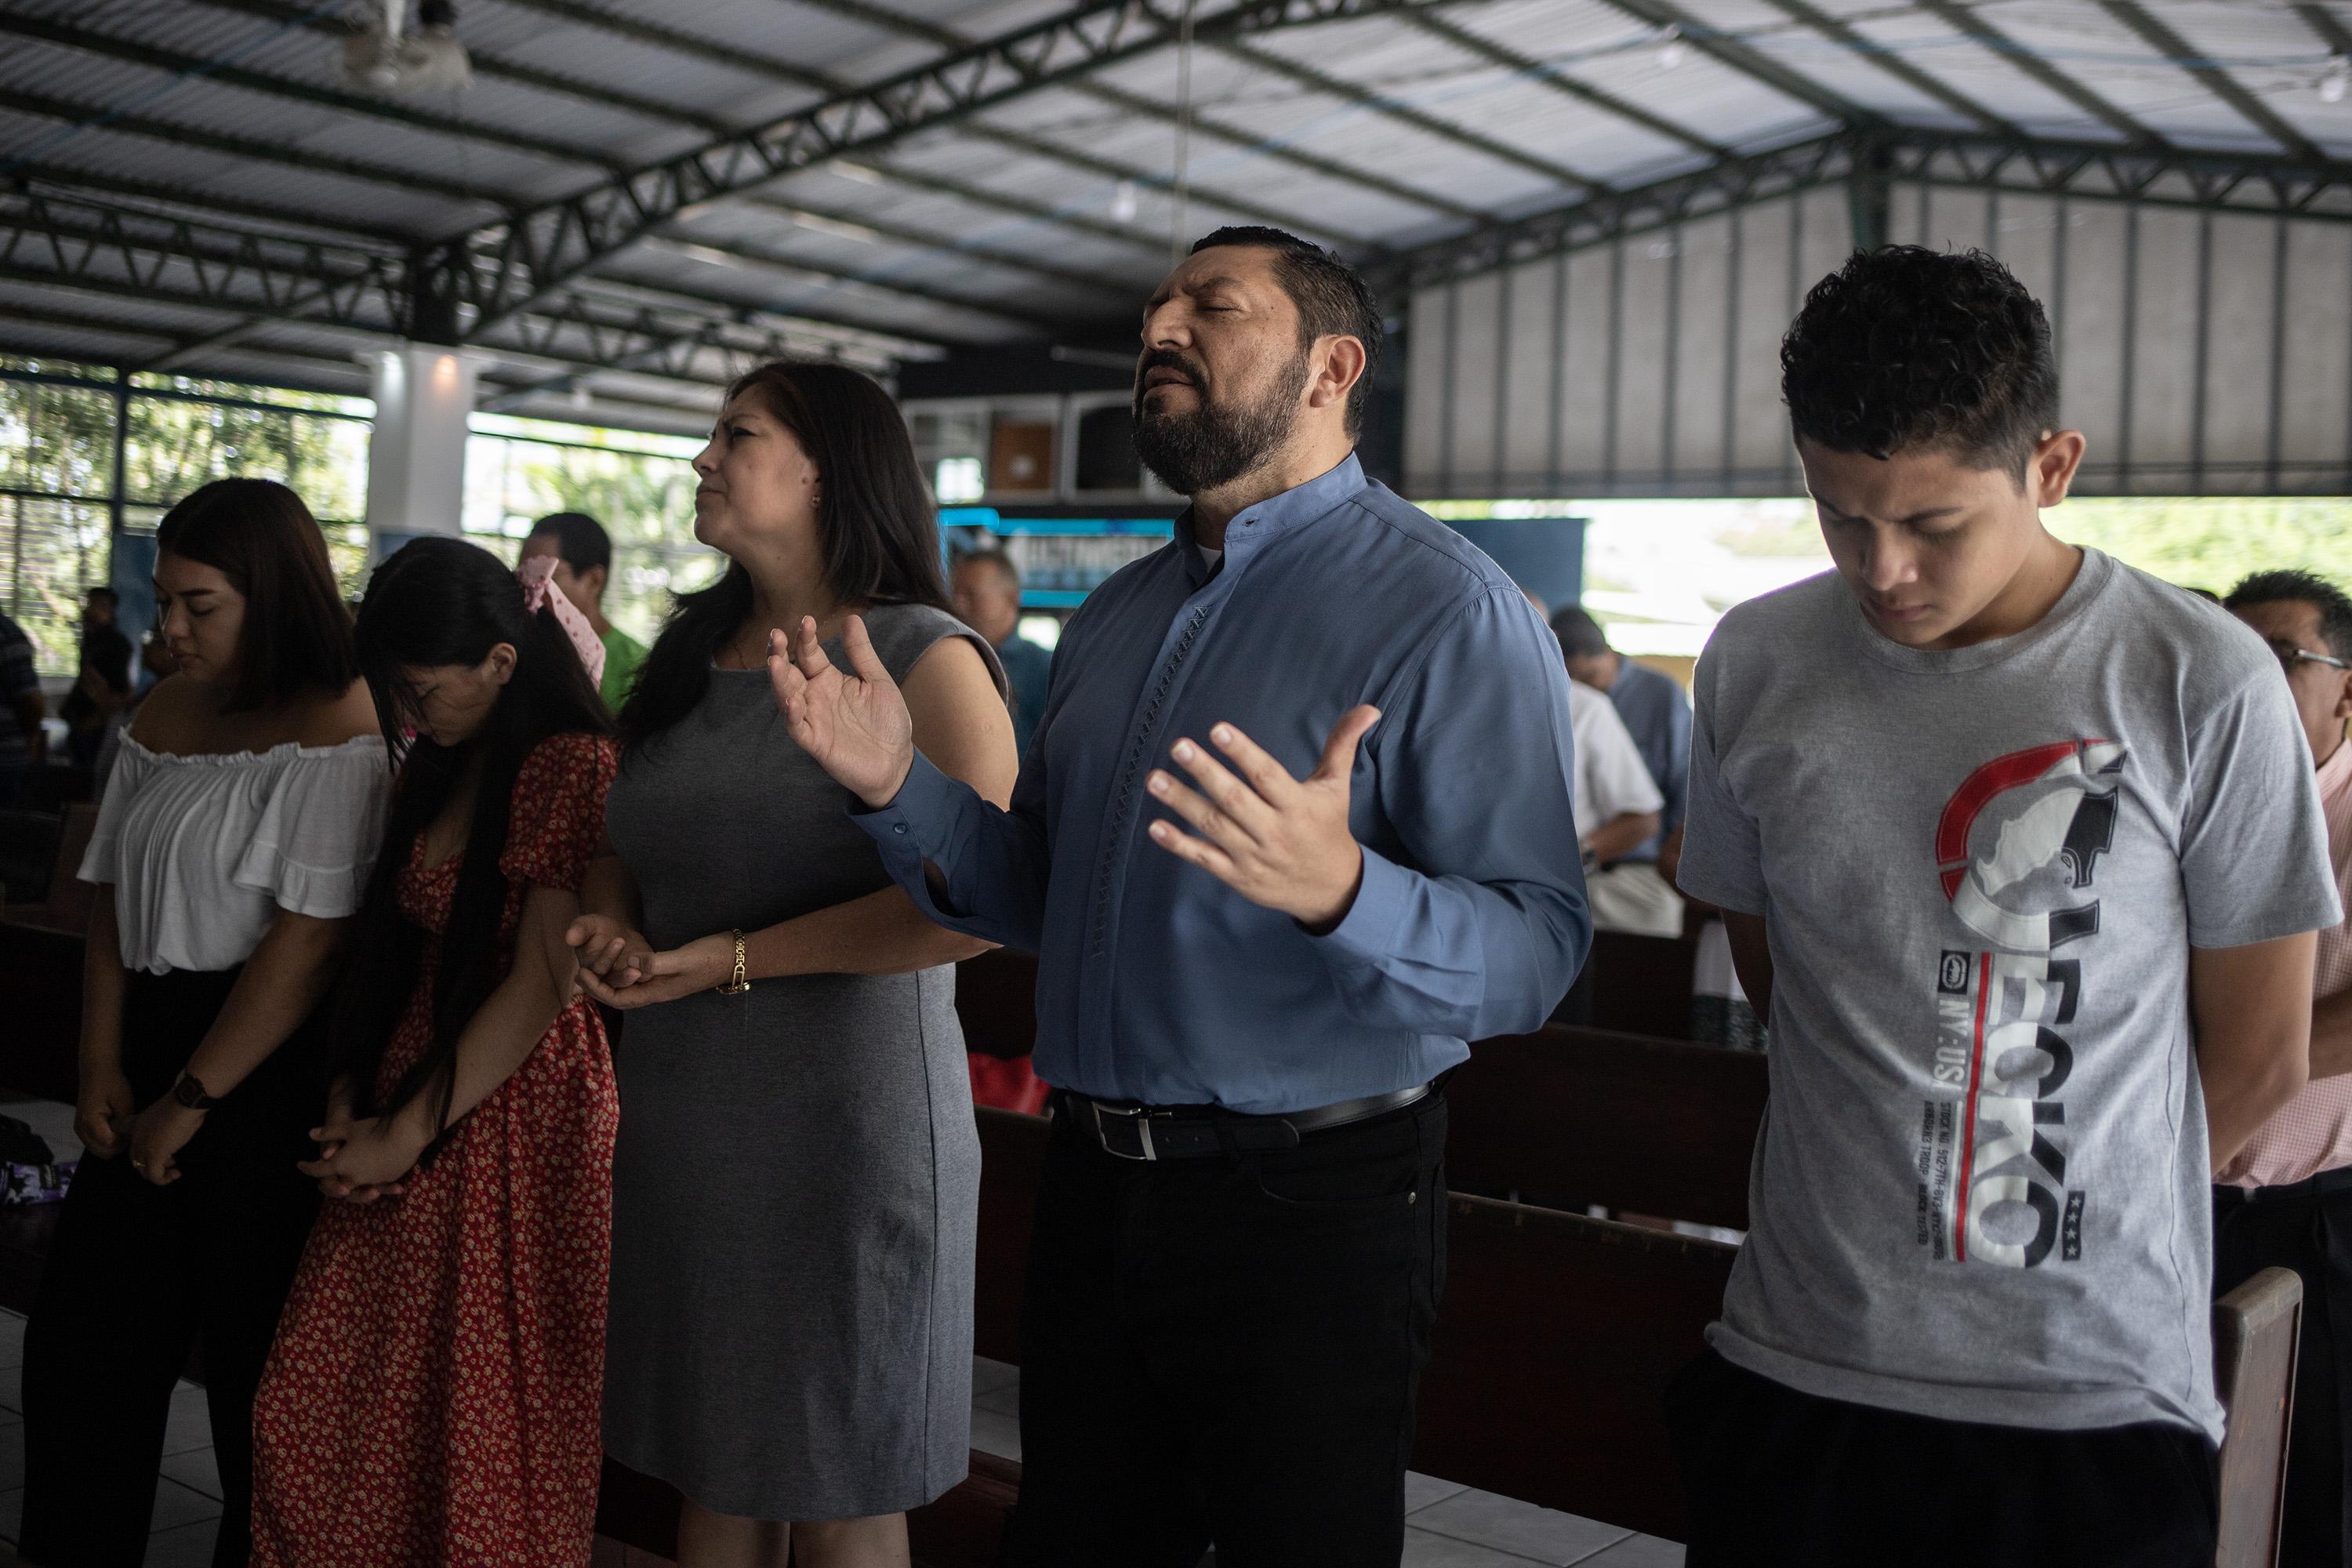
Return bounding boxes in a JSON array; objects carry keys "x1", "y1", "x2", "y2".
[{"x1": 1665, "y1": 1349, "x2": 2220, "y2": 1568}]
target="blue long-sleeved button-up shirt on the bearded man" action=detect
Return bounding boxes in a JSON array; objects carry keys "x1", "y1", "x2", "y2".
[{"x1": 856, "y1": 456, "x2": 1592, "y2": 1114}]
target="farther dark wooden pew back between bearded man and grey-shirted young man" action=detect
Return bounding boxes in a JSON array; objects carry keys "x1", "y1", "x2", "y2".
[{"x1": 1446, "y1": 1027, "x2": 1766, "y2": 1229}]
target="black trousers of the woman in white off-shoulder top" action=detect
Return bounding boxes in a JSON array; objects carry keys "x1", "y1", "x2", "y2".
[{"x1": 19, "y1": 971, "x2": 327, "y2": 1568}]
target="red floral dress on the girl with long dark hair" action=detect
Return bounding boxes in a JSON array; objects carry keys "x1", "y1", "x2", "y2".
[{"x1": 252, "y1": 734, "x2": 619, "y2": 1568}]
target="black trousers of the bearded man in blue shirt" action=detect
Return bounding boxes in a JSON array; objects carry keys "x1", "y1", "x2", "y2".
[{"x1": 1004, "y1": 1093, "x2": 1446, "y2": 1568}]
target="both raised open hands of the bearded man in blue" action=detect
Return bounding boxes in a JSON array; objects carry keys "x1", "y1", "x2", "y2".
[{"x1": 767, "y1": 616, "x2": 1381, "y2": 933}]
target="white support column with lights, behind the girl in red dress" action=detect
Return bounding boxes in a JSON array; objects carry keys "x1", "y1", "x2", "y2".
[{"x1": 367, "y1": 343, "x2": 475, "y2": 560}]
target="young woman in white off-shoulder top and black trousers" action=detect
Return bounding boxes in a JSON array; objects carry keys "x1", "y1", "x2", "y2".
[{"x1": 19, "y1": 480, "x2": 390, "y2": 1568}]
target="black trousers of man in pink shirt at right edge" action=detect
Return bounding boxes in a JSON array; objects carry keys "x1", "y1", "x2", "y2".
[{"x1": 2213, "y1": 1171, "x2": 2352, "y2": 1568}]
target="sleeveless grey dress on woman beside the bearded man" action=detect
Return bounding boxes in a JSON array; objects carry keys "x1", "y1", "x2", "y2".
[{"x1": 604, "y1": 607, "x2": 995, "y2": 1519}]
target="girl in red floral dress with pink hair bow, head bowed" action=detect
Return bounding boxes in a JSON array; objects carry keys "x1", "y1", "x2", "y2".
[{"x1": 252, "y1": 539, "x2": 619, "y2": 1568}]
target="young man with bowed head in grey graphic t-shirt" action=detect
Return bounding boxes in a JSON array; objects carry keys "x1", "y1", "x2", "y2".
[{"x1": 1670, "y1": 247, "x2": 2338, "y2": 1568}]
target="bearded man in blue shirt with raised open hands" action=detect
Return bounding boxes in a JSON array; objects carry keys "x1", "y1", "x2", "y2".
[{"x1": 769, "y1": 228, "x2": 1590, "y2": 1568}]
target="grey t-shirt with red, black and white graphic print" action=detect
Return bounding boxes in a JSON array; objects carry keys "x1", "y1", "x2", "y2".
[{"x1": 1682, "y1": 550, "x2": 2340, "y2": 1441}]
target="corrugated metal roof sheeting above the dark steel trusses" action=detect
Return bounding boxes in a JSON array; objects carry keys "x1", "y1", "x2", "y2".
[{"x1": 13, "y1": 0, "x2": 2352, "y2": 411}]
